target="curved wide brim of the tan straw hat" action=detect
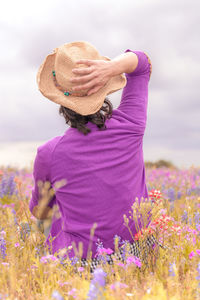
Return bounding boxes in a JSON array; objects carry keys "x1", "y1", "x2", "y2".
[{"x1": 37, "y1": 52, "x2": 126, "y2": 115}]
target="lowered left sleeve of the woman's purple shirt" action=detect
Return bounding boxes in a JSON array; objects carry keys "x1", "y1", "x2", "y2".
[{"x1": 29, "y1": 147, "x2": 56, "y2": 213}]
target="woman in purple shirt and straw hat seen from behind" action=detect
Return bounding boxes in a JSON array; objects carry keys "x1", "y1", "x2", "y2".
[{"x1": 29, "y1": 42, "x2": 156, "y2": 274}]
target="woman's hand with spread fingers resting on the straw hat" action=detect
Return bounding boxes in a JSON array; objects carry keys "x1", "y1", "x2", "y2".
[{"x1": 70, "y1": 59, "x2": 113, "y2": 96}]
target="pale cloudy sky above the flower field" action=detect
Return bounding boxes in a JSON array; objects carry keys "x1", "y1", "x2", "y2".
[{"x1": 0, "y1": 0, "x2": 200, "y2": 166}]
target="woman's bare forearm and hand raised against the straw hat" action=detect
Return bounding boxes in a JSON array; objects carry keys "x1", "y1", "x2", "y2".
[{"x1": 71, "y1": 52, "x2": 138, "y2": 95}]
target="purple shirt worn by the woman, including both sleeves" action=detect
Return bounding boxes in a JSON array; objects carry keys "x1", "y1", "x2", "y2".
[{"x1": 29, "y1": 49, "x2": 151, "y2": 258}]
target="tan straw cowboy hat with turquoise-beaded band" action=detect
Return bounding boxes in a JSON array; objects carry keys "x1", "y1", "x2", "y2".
[{"x1": 37, "y1": 41, "x2": 126, "y2": 115}]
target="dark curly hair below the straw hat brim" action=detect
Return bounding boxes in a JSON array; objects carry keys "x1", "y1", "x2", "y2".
[{"x1": 59, "y1": 97, "x2": 113, "y2": 135}]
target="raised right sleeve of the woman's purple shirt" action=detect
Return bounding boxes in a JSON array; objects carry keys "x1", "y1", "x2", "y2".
[{"x1": 118, "y1": 49, "x2": 152, "y2": 134}]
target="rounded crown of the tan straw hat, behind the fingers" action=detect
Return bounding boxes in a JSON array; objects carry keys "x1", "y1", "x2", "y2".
[{"x1": 54, "y1": 42, "x2": 102, "y2": 95}]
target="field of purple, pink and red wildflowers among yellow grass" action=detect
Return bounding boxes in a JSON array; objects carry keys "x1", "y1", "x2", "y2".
[{"x1": 0, "y1": 167, "x2": 200, "y2": 300}]
